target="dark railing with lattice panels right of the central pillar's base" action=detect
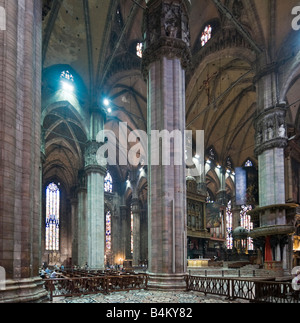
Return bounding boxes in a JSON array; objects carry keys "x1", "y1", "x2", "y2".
[{"x1": 187, "y1": 276, "x2": 300, "y2": 303}]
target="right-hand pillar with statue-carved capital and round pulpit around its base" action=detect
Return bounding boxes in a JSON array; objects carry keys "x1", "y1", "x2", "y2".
[{"x1": 251, "y1": 63, "x2": 294, "y2": 270}]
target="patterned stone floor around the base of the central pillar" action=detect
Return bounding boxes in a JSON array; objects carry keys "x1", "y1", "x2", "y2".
[{"x1": 53, "y1": 291, "x2": 247, "y2": 304}]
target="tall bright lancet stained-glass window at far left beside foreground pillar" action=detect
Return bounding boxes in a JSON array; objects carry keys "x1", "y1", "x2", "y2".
[{"x1": 46, "y1": 183, "x2": 60, "y2": 251}]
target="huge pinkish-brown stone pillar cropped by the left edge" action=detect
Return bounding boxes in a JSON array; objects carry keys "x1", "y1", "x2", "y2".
[{"x1": 0, "y1": 0, "x2": 45, "y2": 302}]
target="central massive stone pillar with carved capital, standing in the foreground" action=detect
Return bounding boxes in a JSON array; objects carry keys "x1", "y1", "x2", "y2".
[{"x1": 143, "y1": 0, "x2": 190, "y2": 290}]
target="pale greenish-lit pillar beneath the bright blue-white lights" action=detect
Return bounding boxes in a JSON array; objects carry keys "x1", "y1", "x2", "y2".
[{"x1": 85, "y1": 109, "x2": 106, "y2": 270}]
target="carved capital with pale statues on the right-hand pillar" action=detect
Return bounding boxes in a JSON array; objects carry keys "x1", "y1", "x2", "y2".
[{"x1": 254, "y1": 106, "x2": 288, "y2": 156}]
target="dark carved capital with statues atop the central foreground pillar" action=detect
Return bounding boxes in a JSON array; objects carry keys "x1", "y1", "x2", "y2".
[{"x1": 142, "y1": 0, "x2": 191, "y2": 78}]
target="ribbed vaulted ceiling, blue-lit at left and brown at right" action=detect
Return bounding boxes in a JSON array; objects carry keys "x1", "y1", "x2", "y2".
[{"x1": 42, "y1": 0, "x2": 299, "y2": 195}]
